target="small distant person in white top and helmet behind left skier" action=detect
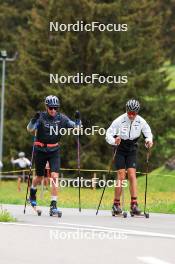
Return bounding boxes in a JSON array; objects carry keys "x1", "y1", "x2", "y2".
[{"x1": 11, "y1": 152, "x2": 30, "y2": 192}]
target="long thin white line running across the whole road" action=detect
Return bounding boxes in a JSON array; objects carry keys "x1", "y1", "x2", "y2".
[{"x1": 0, "y1": 223, "x2": 175, "y2": 239}]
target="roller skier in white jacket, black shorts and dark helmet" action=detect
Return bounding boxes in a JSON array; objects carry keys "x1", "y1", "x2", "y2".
[{"x1": 106, "y1": 99, "x2": 153, "y2": 215}]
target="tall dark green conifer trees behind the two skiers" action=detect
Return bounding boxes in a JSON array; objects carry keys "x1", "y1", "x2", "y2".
[{"x1": 0, "y1": 0, "x2": 174, "y2": 169}]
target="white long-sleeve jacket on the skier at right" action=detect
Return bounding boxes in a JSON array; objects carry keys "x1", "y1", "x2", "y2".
[{"x1": 106, "y1": 113, "x2": 153, "y2": 145}]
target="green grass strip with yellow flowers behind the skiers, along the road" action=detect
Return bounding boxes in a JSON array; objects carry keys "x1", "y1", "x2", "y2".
[{"x1": 0, "y1": 167, "x2": 175, "y2": 213}]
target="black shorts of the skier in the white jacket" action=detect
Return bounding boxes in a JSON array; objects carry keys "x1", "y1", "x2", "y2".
[{"x1": 115, "y1": 151, "x2": 137, "y2": 170}]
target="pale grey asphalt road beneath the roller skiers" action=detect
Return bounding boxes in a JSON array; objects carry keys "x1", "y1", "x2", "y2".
[{"x1": 0, "y1": 205, "x2": 175, "y2": 264}]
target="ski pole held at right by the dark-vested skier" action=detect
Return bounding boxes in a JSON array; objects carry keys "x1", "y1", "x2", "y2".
[{"x1": 75, "y1": 110, "x2": 81, "y2": 212}]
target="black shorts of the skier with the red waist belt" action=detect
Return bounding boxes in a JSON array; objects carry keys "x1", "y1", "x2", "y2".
[{"x1": 35, "y1": 150, "x2": 60, "y2": 176}]
